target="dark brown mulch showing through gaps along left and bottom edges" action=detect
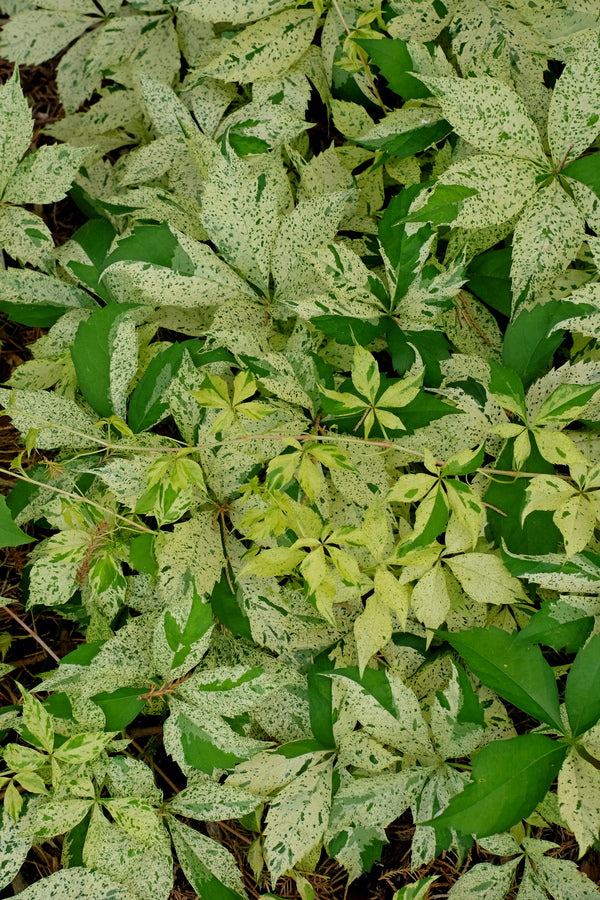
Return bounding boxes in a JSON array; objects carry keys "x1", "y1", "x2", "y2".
[{"x1": 0, "y1": 49, "x2": 600, "y2": 900}]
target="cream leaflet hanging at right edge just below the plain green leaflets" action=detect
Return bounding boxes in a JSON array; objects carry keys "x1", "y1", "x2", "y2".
[{"x1": 558, "y1": 748, "x2": 600, "y2": 856}]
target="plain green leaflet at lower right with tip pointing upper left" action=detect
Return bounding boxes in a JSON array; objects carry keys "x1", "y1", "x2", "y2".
[{"x1": 443, "y1": 626, "x2": 563, "y2": 733}]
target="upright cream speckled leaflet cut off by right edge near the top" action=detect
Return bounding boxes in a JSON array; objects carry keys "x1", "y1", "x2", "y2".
[{"x1": 548, "y1": 42, "x2": 600, "y2": 166}]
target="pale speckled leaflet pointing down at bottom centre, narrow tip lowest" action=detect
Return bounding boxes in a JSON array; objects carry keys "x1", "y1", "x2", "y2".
[{"x1": 264, "y1": 760, "x2": 332, "y2": 884}]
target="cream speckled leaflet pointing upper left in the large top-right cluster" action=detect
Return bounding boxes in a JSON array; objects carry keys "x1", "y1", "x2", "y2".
[{"x1": 416, "y1": 75, "x2": 546, "y2": 165}]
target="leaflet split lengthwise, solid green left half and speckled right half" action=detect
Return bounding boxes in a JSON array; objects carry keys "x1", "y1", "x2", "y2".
[{"x1": 71, "y1": 303, "x2": 137, "y2": 419}]
